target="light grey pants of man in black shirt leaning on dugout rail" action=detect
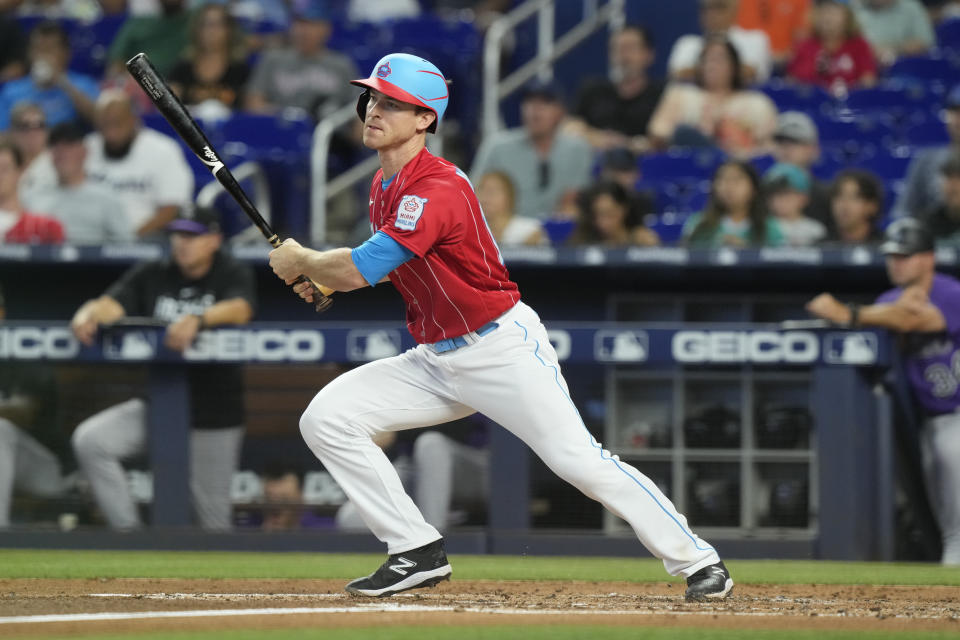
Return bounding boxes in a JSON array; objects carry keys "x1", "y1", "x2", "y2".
[{"x1": 71, "y1": 398, "x2": 243, "y2": 530}]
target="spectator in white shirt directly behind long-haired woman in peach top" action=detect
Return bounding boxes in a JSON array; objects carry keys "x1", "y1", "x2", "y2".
[{"x1": 667, "y1": 0, "x2": 773, "y2": 85}]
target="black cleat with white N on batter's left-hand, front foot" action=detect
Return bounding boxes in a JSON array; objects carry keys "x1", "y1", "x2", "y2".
[{"x1": 346, "y1": 538, "x2": 452, "y2": 598}]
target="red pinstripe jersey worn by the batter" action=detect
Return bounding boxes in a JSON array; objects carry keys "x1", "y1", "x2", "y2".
[{"x1": 370, "y1": 148, "x2": 520, "y2": 343}]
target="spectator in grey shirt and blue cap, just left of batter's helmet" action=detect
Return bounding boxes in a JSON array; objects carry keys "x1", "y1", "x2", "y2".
[{"x1": 244, "y1": 0, "x2": 359, "y2": 119}]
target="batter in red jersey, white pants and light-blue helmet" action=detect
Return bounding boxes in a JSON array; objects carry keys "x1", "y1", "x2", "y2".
[{"x1": 270, "y1": 53, "x2": 733, "y2": 600}]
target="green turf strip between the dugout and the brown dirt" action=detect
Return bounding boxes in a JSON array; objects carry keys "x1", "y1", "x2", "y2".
[{"x1": 0, "y1": 549, "x2": 960, "y2": 586}]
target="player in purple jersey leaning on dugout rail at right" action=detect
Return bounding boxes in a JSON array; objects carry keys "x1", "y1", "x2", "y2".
[{"x1": 807, "y1": 218, "x2": 960, "y2": 565}]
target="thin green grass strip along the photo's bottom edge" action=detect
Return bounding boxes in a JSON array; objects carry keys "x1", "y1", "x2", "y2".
[{"x1": 20, "y1": 625, "x2": 957, "y2": 640}]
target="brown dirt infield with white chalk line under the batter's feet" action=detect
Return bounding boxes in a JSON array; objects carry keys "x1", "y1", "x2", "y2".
[{"x1": 0, "y1": 579, "x2": 960, "y2": 637}]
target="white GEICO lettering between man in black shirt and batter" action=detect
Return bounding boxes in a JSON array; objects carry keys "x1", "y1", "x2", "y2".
[{"x1": 183, "y1": 329, "x2": 324, "y2": 362}]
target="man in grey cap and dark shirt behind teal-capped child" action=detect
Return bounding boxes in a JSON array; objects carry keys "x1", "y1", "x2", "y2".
[{"x1": 773, "y1": 111, "x2": 833, "y2": 227}]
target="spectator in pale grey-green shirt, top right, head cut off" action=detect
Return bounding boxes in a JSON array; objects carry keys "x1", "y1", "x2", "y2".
[{"x1": 853, "y1": 0, "x2": 936, "y2": 66}]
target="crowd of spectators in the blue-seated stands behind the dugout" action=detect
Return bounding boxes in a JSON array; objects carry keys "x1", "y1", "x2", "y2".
[{"x1": 0, "y1": 0, "x2": 960, "y2": 252}]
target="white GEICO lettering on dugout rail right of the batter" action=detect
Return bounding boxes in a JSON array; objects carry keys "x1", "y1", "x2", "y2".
[{"x1": 673, "y1": 331, "x2": 820, "y2": 363}]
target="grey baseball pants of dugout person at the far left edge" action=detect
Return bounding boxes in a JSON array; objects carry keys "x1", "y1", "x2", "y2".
[{"x1": 0, "y1": 418, "x2": 63, "y2": 529}]
